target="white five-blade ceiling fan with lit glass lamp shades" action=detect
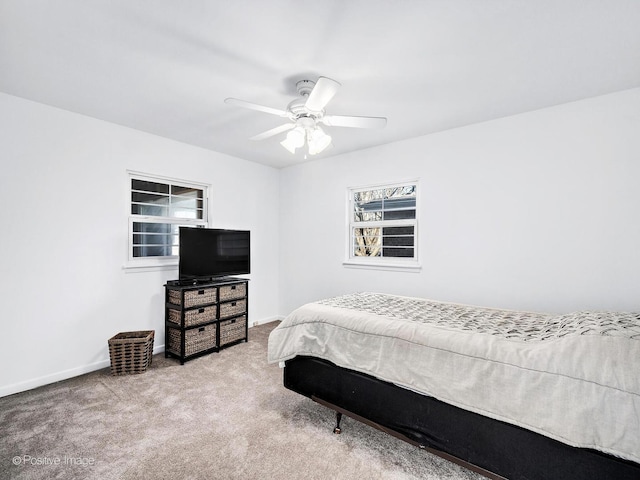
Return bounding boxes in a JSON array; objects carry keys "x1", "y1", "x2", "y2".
[{"x1": 225, "y1": 77, "x2": 387, "y2": 155}]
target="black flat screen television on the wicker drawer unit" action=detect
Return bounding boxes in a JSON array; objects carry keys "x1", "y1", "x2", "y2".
[{"x1": 178, "y1": 227, "x2": 251, "y2": 282}]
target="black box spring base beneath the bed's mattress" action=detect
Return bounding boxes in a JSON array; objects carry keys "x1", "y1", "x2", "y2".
[{"x1": 284, "y1": 356, "x2": 640, "y2": 480}]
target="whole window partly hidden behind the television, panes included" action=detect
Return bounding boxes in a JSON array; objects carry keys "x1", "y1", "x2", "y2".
[{"x1": 129, "y1": 173, "x2": 208, "y2": 266}]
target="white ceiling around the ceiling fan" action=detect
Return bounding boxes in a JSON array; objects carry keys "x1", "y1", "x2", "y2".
[{"x1": 0, "y1": 0, "x2": 640, "y2": 167}]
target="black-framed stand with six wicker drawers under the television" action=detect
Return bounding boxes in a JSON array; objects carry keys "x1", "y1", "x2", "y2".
[{"x1": 164, "y1": 277, "x2": 249, "y2": 365}]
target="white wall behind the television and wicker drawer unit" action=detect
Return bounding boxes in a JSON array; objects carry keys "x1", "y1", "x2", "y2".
[{"x1": 0, "y1": 94, "x2": 279, "y2": 396}]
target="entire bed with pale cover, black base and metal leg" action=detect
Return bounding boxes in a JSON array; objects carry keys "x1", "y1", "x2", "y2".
[{"x1": 268, "y1": 292, "x2": 640, "y2": 480}]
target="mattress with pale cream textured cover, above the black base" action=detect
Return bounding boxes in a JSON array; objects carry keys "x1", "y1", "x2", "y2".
[{"x1": 268, "y1": 293, "x2": 640, "y2": 463}]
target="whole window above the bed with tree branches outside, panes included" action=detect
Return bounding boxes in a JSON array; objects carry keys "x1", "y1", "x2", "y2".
[{"x1": 346, "y1": 182, "x2": 418, "y2": 267}]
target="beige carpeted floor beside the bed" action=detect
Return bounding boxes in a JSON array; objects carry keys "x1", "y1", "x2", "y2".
[{"x1": 0, "y1": 322, "x2": 483, "y2": 480}]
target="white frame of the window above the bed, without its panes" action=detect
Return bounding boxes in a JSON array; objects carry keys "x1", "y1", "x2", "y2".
[{"x1": 342, "y1": 179, "x2": 422, "y2": 272}]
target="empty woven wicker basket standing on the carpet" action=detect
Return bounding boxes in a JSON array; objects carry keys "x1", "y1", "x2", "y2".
[{"x1": 109, "y1": 330, "x2": 155, "y2": 375}]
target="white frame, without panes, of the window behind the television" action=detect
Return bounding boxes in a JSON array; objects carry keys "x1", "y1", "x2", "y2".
[{"x1": 124, "y1": 170, "x2": 211, "y2": 271}]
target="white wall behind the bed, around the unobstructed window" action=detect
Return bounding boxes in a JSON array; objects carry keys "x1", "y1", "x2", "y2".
[{"x1": 280, "y1": 89, "x2": 640, "y2": 314}]
